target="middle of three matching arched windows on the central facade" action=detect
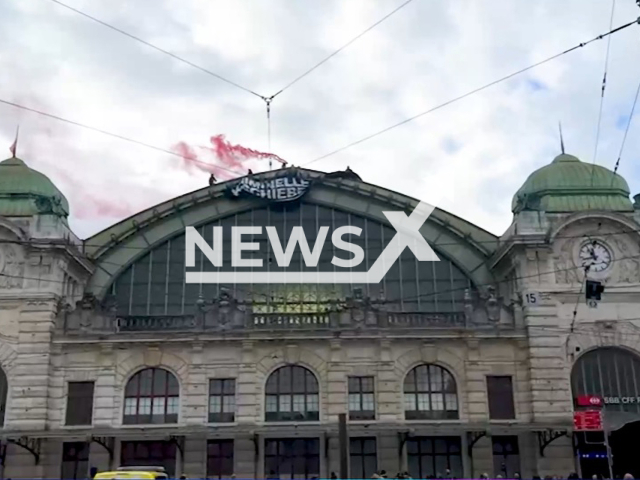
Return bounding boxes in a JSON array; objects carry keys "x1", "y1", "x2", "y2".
[{"x1": 265, "y1": 365, "x2": 320, "y2": 422}]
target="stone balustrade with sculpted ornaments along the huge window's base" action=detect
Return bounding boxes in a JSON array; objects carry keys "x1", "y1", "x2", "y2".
[{"x1": 56, "y1": 287, "x2": 514, "y2": 335}]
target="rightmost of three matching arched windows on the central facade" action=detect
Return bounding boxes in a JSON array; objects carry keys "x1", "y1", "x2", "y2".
[{"x1": 404, "y1": 365, "x2": 458, "y2": 420}]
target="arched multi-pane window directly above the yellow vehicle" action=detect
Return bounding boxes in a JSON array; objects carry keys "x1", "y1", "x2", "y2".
[{"x1": 123, "y1": 368, "x2": 180, "y2": 425}]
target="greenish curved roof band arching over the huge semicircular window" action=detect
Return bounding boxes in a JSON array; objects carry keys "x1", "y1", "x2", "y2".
[{"x1": 86, "y1": 170, "x2": 497, "y2": 298}]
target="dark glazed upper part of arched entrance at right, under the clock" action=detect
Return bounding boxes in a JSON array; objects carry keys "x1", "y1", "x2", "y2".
[{"x1": 571, "y1": 347, "x2": 640, "y2": 413}]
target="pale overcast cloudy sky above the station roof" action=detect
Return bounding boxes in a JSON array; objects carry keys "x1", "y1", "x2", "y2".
[{"x1": 0, "y1": 0, "x2": 640, "y2": 238}]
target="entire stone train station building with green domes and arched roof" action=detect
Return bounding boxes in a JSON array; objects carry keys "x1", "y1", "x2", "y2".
[{"x1": 0, "y1": 154, "x2": 640, "y2": 479}]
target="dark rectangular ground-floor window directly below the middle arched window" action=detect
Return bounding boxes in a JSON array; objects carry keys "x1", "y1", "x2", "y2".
[{"x1": 264, "y1": 438, "x2": 320, "y2": 480}]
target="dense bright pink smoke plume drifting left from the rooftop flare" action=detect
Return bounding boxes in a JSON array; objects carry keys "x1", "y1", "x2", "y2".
[{"x1": 172, "y1": 135, "x2": 287, "y2": 180}]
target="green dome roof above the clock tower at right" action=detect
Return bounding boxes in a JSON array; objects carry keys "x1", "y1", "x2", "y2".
[{"x1": 511, "y1": 153, "x2": 633, "y2": 213}]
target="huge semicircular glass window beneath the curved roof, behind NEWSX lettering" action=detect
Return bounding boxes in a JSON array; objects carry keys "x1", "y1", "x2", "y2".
[{"x1": 110, "y1": 201, "x2": 473, "y2": 316}]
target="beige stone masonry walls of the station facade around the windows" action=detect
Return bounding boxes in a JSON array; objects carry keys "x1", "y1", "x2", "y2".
[{"x1": 0, "y1": 163, "x2": 640, "y2": 478}]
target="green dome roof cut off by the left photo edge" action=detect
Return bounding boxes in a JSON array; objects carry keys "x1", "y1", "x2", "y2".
[{"x1": 0, "y1": 157, "x2": 69, "y2": 218}]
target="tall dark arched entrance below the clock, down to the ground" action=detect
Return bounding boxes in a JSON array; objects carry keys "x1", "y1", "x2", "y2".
[{"x1": 571, "y1": 347, "x2": 640, "y2": 478}]
